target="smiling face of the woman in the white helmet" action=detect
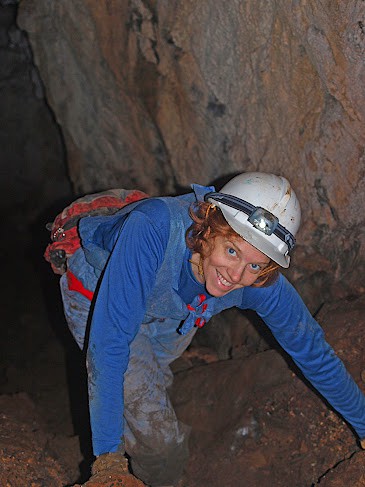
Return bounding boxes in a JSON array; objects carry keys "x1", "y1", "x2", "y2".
[{"x1": 193, "y1": 236, "x2": 270, "y2": 298}]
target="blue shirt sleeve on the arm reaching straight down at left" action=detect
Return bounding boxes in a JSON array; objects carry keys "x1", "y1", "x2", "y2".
[{"x1": 87, "y1": 201, "x2": 170, "y2": 455}]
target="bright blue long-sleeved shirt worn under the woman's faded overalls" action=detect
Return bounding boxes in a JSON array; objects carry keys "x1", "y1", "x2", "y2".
[{"x1": 84, "y1": 200, "x2": 365, "y2": 455}]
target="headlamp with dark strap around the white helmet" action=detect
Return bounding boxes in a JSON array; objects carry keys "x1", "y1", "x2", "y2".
[{"x1": 204, "y1": 192, "x2": 295, "y2": 251}]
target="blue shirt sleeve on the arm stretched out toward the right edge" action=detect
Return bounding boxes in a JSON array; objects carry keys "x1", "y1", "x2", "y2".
[{"x1": 240, "y1": 275, "x2": 365, "y2": 438}]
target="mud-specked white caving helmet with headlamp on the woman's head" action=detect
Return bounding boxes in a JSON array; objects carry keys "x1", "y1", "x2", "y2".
[{"x1": 205, "y1": 172, "x2": 300, "y2": 268}]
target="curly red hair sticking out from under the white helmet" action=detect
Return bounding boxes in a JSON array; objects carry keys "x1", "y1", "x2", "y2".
[{"x1": 186, "y1": 202, "x2": 279, "y2": 287}]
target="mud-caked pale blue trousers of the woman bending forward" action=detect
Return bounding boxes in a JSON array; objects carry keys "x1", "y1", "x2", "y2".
[{"x1": 60, "y1": 274, "x2": 196, "y2": 487}]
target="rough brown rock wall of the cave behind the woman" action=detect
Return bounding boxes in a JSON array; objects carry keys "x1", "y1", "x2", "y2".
[{"x1": 18, "y1": 0, "x2": 365, "y2": 309}]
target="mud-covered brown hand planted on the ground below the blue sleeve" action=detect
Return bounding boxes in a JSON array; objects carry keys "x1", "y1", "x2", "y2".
[{"x1": 74, "y1": 453, "x2": 145, "y2": 487}]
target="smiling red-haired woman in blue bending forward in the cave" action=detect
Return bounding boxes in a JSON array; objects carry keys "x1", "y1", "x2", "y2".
[{"x1": 61, "y1": 172, "x2": 365, "y2": 487}]
